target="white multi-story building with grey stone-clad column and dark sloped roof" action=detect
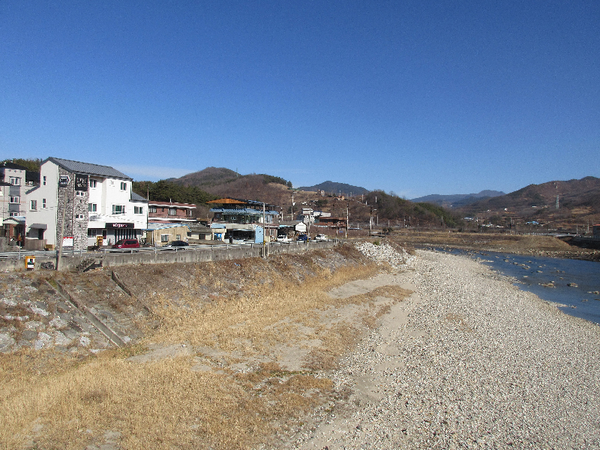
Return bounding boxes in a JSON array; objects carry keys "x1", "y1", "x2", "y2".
[{"x1": 27, "y1": 158, "x2": 148, "y2": 250}]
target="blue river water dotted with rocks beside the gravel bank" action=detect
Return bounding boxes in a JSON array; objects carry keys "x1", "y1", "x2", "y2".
[{"x1": 434, "y1": 250, "x2": 600, "y2": 324}]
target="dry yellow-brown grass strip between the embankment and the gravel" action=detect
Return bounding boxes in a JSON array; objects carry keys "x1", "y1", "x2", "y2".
[{"x1": 0, "y1": 246, "x2": 408, "y2": 449}]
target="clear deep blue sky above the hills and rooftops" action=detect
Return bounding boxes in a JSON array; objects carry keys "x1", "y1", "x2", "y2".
[{"x1": 0, "y1": 0, "x2": 600, "y2": 198}]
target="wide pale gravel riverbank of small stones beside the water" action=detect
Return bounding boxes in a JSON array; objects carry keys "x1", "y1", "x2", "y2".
[{"x1": 287, "y1": 251, "x2": 600, "y2": 450}]
